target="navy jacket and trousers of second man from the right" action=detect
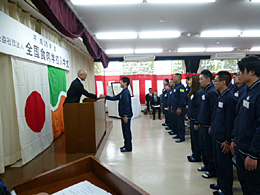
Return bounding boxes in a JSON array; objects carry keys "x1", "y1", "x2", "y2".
[{"x1": 210, "y1": 89, "x2": 237, "y2": 195}]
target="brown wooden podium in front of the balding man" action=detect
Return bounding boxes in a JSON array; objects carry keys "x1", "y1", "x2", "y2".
[{"x1": 63, "y1": 98, "x2": 106, "y2": 153}]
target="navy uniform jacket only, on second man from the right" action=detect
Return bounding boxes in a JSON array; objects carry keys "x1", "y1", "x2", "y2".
[{"x1": 210, "y1": 89, "x2": 237, "y2": 144}]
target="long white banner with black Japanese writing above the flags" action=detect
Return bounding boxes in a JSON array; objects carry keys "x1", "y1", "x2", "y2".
[{"x1": 0, "y1": 12, "x2": 70, "y2": 70}]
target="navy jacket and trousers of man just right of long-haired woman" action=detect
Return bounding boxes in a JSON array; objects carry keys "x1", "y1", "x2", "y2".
[{"x1": 198, "y1": 83, "x2": 218, "y2": 175}]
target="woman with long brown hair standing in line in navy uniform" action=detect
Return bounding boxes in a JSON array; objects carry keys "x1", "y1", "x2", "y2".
[{"x1": 187, "y1": 75, "x2": 202, "y2": 162}]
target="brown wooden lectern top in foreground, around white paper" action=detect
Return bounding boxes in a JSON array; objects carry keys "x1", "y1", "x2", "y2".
[{"x1": 13, "y1": 156, "x2": 148, "y2": 195}]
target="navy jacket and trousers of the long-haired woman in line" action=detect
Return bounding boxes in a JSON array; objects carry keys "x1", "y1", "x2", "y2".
[{"x1": 188, "y1": 89, "x2": 202, "y2": 160}]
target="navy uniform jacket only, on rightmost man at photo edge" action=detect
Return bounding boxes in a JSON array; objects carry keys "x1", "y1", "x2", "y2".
[{"x1": 234, "y1": 80, "x2": 260, "y2": 159}]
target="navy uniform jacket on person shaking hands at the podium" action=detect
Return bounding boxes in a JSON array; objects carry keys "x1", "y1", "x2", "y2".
[{"x1": 106, "y1": 87, "x2": 133, "y2": 118}]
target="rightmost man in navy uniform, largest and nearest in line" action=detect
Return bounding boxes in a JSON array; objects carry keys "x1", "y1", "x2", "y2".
[{"x1": 231, "y1": 56, "x2": 260, "y2": 195}]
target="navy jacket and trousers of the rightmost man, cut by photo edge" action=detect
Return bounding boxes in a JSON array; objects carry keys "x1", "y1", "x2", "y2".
[{"x1": 234, "y1": 80, "x2": 260, "y2": 194}]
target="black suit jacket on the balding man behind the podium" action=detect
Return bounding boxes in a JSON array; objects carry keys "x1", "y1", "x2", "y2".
[{"x1": 63, "y1": 78, "x2": 97, "y2": 105}]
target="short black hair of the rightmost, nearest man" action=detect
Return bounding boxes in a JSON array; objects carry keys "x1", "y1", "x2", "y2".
[{"x1": 237, "y1": 55, "x2": 260, "y2": 77}]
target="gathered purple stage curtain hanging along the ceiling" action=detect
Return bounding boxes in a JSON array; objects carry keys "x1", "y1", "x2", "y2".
[{"x1": 32, "y1": 0, "x2": 109, "y2": 68}]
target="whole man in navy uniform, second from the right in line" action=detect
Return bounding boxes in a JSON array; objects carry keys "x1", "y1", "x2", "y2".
[{"x1": 210, "y1": 71, "x2": 237, "y2": 195}]
